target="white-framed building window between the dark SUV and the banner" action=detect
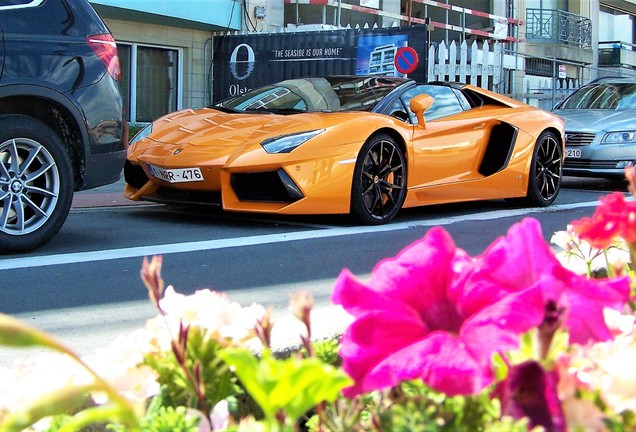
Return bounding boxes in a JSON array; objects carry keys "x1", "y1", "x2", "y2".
[{"x1": 117, "y1": 43, "x2": 182, "y2": 122}]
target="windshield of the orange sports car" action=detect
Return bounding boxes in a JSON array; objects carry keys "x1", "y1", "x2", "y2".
[{"x1": 217, "y1": 76, "x2": 405, "y2": 113}]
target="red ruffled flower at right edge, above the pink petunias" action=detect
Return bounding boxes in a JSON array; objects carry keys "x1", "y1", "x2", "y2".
[{"x1": 572, "y1": 192, "x2": 636, "y2": 249}]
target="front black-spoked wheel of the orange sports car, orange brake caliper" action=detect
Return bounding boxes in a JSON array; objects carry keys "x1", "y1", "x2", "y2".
[{"x1": 351, "y1": 134, "x2": 406, "y2": 225}]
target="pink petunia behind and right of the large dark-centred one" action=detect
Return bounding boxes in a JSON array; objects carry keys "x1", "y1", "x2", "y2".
[{"x1": 468, "y1": 218, "x2": 630, "y2": 343}]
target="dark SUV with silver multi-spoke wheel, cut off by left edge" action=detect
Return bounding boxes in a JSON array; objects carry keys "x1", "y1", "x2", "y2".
[{"x1": 0, "y1": 0, "x2": 128, "y2": 251}]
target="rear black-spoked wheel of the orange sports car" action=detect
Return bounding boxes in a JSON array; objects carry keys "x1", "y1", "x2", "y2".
[{"x1": 523, "y1": 131, "x2": 563, "y2": 207}]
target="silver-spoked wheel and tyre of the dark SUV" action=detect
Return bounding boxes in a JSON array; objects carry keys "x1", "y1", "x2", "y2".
[{"x1": 0, "y1": 115, "x2": 74, "y2": 252}]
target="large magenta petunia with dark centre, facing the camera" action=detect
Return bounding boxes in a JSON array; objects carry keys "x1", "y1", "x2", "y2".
[{"x1": 333, "y1": 227, "x2": 544, "y2": 397}]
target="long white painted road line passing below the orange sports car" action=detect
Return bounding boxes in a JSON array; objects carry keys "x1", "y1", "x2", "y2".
[{"x1": 0, "y1": 201, "x2": 598, "y2": 270}]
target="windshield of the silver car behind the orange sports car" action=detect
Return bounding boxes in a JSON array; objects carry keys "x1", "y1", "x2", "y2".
[{"x1": 559, "y1": 83, "x2": 636, "y2": 111}]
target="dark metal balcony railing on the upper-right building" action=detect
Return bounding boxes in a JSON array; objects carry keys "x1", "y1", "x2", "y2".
[{"x1": 526, "y1": 9, "x2": 592, "y2": 48}]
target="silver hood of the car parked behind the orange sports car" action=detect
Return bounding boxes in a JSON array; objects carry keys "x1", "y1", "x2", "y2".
[{"x1": 554, "y1": 109, "x2": 636, "y2": 132}]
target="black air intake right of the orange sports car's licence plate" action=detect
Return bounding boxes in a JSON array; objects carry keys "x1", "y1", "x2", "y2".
[{"x1": 230, "y1": 169, "x2": 304, "y2": 203}]
